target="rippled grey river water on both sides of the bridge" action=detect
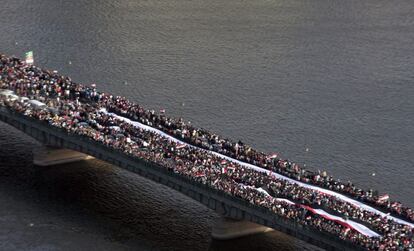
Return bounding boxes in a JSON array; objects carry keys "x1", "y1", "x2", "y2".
[{"x1": 0, "y1": 0, "x2": 414, "y2": 251}]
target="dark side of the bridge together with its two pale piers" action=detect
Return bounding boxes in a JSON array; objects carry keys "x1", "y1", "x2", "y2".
[{"x1": 0, "y1": 106, "x2": 363, "y2": 250}]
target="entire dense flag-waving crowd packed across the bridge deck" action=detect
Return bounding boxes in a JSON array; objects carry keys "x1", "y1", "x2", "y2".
[{"x1": 0, "y1": 55, "x2": 414, "y2": 250}]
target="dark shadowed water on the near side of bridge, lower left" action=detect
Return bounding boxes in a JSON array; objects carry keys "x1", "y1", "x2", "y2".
[{"x1": 0, "y1": 124, "x2": 315, "y2": 251}]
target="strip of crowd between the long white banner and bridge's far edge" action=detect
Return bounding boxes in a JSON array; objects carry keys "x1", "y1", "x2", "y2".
[{"x1": 102, "y1": 97, "x2": 414, "y2": 222}]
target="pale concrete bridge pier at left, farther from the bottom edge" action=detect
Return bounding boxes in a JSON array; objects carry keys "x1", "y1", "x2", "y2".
[{"x1": 33, "y1": 146, "x2": 93, "y2": 166}]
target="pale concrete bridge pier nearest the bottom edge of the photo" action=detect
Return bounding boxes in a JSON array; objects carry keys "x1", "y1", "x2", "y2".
[{"x1": 211, "y1": 217, "x2": 274, "y2": 240}]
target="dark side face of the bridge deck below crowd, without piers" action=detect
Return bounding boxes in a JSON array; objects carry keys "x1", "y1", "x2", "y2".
[{"x1": 0, "y1": 106, "x2": 364, "y2": 250}]
